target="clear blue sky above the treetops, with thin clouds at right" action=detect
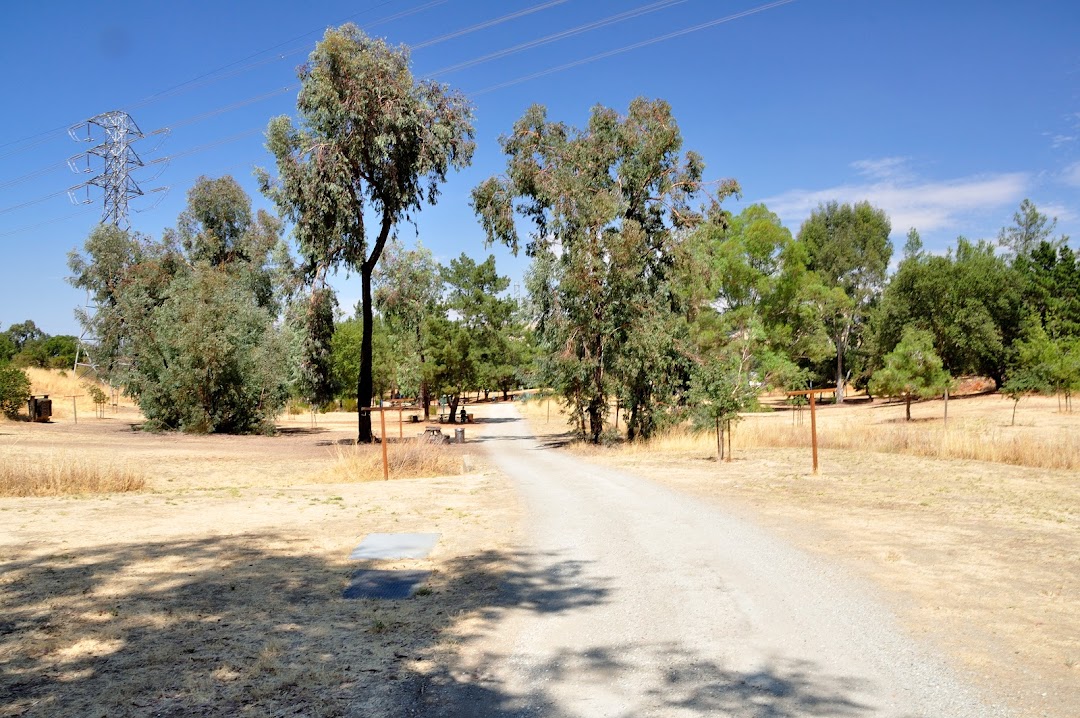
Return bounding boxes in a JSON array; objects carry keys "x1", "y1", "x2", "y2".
[{"x1": 0, "y1": 0, "x2": 1080, "y2": 334}]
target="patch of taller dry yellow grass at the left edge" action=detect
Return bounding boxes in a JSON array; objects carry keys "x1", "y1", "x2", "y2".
[{"x1": 0, "y1": 451, "x2": 146, "y2": 497}]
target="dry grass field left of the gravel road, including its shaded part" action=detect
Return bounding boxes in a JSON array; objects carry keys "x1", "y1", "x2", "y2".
[{"x1": 0, "y1": 388, "x2": 528, "y2": 718}]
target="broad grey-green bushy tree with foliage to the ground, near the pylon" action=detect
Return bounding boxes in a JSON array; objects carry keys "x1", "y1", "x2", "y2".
[{"x1": 69, "y1": 178, "x2": 288, "y2": 433}]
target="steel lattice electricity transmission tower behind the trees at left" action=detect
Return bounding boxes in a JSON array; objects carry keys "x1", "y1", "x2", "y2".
[{"x1": 68, "y1": 110, "x2": 168, "y2": 376}]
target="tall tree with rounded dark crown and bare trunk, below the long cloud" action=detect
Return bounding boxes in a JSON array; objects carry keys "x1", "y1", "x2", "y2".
[{"x1": 798, "y1": 202, "x2": 892, "y2": 404}]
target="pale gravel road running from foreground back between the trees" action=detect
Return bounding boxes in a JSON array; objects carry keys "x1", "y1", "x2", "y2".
[{"x1": 413, "y1": 405, "x2": 1009, "y2": 718}]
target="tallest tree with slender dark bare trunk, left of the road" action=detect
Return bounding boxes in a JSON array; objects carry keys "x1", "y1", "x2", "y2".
[{"x1": 259, "y1": 24, "x2": 474, "y2": 443}]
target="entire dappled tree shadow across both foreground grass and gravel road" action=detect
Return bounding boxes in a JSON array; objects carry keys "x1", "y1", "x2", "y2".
[{"x1": 0, "y1": 526, "x2": 894, "y2": 718}]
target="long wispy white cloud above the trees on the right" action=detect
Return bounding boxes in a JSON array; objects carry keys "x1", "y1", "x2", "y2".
[{"x1": 762, "y1": 169, "x2": 1031, "y2": 234}]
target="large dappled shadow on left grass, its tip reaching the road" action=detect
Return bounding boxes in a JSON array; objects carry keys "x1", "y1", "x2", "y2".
[{"x1": 0, "y1": 533, "x2": 607, "y2": 717}]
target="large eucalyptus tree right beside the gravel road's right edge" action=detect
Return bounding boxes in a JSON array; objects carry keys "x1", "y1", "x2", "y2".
[{"x1": 472, "y1": 99, "x2": 738, "y2": 442}]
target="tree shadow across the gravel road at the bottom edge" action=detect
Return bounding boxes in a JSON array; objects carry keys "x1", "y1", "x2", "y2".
[{"x1": 407, "y1": 645, "x2": 880, "y2": 718}]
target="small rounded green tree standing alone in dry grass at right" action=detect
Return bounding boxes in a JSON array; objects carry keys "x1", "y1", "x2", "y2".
[{"x1": 870, "y1": 327, "x2": 950, "y2": 421}]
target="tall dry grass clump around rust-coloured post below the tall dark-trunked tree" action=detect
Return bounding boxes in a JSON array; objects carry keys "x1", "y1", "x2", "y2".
[{"x1": 319, "y1": 439, "x2": 463, "y2": 484}]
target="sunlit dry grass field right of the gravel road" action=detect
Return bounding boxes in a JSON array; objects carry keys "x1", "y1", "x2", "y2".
[{"x1": 516, "y1": 395, "x2": 1080, "y2": 718}]
